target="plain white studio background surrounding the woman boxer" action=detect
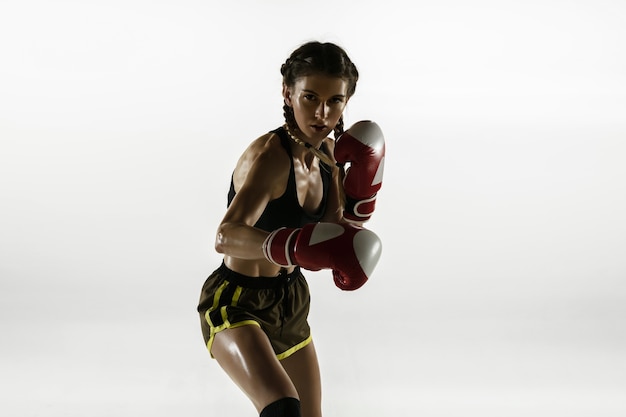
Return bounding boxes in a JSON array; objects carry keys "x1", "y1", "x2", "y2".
[{"x1": 0, "y1": 0, "x2": 626, "y2": 417}]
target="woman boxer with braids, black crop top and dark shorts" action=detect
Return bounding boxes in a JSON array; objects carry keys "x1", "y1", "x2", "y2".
[{"x1": 198, "y1": 42, "x2": 380, "y2": 417}]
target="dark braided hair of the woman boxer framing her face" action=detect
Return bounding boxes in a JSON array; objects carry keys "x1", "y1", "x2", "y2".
[{"x1": 280, "y1": 41, "x2": 359, "y2": 141}]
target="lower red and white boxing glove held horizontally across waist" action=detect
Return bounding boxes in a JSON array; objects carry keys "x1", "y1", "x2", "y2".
[{"x1": 263, "y1": 223, "x2": 382, "y2": 290}]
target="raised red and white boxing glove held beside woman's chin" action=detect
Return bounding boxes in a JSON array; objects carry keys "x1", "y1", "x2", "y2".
[{"x1": 334, "y1": 120, "x2": 385, "y2": 222}]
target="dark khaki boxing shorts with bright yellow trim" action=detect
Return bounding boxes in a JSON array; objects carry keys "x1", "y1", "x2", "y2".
[{"x1": 198, "y1": 263, "x2": 311, "y2": 360}]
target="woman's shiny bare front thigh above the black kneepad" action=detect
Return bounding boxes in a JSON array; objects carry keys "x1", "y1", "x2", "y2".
[{"x1": 211, "y1": 325, "x2": 299, "y2": 413}]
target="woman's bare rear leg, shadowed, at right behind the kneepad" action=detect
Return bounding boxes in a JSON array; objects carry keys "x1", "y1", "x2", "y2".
[{"x1": 280, "y1": 342, "x2": 322, "y2": 417}]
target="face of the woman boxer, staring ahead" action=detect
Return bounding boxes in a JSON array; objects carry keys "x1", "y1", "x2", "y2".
[{"x1": 283, "y1": 74, "x2": 348, "y2": 140}]
